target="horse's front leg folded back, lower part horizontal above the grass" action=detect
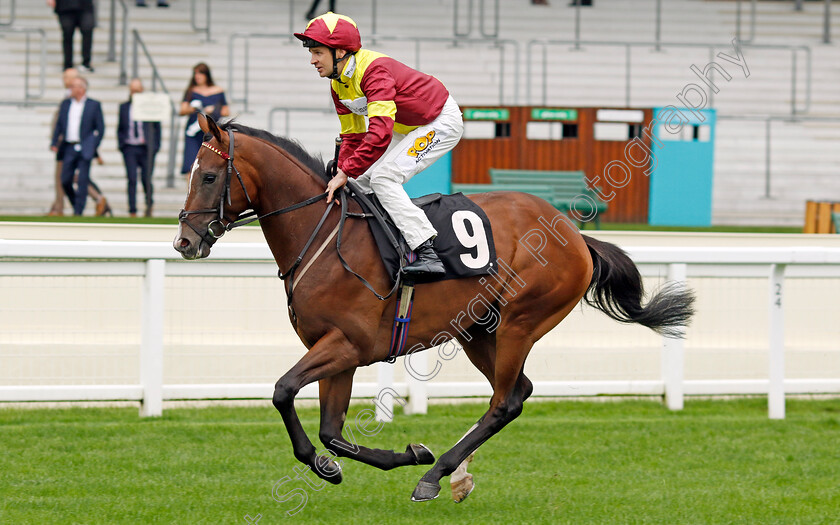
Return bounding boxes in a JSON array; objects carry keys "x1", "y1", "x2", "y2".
[{"x1": 319, "y1": 369, "x2": 435, "y2": 470}]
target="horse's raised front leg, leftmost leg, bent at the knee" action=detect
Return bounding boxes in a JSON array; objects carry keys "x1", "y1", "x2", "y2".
[{"x1": 272, "y1": 330, "x2": 359, "y2": 485}]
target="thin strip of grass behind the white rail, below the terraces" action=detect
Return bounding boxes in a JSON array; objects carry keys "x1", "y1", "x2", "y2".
[{"x1": 0, "y1": 215, "x2": 802, "y2": 233}]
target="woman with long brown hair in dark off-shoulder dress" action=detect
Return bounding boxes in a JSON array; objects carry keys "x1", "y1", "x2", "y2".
[{"x1": 180, "y1": 62, "x2": 230, "y2": 174}]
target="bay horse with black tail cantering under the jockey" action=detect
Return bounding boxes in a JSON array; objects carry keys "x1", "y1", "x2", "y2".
[{"x1": 173, "y1": 115, "x2": 694, "y2": 501}]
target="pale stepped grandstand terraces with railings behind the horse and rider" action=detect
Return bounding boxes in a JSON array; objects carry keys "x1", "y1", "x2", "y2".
[{"x1": 0, "y1": 0, "x2": 840, "y2": 226}]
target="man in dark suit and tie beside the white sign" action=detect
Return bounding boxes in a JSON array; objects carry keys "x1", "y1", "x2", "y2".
[{"x1": 117, "y1": 78, "x2": 160, "y2": 217}]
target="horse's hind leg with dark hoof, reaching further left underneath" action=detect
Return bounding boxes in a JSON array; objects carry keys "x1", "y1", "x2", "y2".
[{"x1": 411, "y1": 330, "x2": 531, "y2": 501}]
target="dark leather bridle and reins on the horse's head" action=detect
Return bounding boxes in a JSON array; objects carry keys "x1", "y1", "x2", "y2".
[{"x1": 178, "y1": 128, "x2": 332, "y2": 246}]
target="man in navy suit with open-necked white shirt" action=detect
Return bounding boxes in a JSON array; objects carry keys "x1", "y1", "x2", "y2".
[{"x1": 50, "y1": 77, "x2": 105, "y2": 215}]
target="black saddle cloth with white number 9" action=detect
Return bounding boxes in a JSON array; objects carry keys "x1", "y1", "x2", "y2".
[{"x1": 354, "y1": 189, "x2": 496, "y2": 282}]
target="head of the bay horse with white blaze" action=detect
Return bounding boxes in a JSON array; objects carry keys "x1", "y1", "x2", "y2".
[{"x1": 172, "y1": 114, "x2": 254, "y2": 259}]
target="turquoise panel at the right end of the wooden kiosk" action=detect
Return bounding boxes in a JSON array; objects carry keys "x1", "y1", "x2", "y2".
[{"x1": 648, "y1": 106, "x2": 716, "y2": 226}]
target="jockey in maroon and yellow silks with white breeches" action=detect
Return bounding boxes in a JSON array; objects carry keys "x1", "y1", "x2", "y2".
[{"x1": 295, "y1": 12, "x2": 464, "y2": 275}]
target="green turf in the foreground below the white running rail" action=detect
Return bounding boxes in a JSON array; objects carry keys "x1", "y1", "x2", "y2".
[{"x1": 0, "y1": 399, "x2": 840, "y2": 525}]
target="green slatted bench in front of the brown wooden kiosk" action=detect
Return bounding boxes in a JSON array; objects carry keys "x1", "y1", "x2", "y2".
[{"x1": 490, "y1": 169, "x2": 607, "y2": 229}]
